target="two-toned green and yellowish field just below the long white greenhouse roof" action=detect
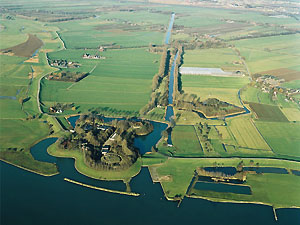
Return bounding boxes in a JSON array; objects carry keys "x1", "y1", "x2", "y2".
[{"x1": 181, "y1": 75, "x2": 249, "y2": 106}]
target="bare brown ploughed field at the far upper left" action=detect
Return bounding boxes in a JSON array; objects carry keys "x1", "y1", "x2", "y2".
[{"x1": 0, "y1": 34, "x2": 43, "y2": 57}]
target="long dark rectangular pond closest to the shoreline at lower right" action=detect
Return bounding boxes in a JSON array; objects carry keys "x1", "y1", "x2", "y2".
[{"x1": 194, "y1": 181, "x2": 251, "y2": 195}]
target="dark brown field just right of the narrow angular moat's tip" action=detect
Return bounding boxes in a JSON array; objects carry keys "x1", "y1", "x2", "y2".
[{"x1": 247, "y1": 102, "x2": 288, "y2": 122}]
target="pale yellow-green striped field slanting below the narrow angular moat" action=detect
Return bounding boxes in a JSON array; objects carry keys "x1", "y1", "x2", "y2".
[{"x1": 228, "y1": 116, "x2": 270, "y2": 150}]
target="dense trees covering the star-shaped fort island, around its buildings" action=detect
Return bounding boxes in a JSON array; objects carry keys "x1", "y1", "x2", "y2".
[{"x1": 59, "y1": 113, "x2": 153, "y2": 170}]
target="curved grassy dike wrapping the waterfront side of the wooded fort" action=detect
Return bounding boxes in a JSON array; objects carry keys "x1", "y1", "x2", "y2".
[{"x1": 47, "y1": 143, "x2": 142, "y2": 182}]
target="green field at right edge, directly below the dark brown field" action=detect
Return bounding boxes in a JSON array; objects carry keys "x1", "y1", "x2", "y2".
[{"x1": 255, "y1": 121, "x2": 300, "y2": 158}]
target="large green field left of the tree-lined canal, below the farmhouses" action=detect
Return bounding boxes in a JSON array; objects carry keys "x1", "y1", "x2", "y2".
[{"x1": 41, "y1": 49, "x2": 160, "y2": 113}]
